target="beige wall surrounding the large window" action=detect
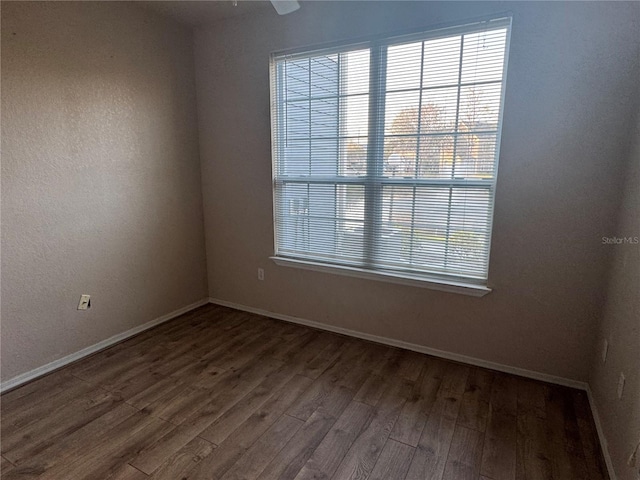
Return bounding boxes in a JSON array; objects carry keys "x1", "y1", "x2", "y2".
[{"x1": 195, "y1": 2, "x2": 640, "y2": 381}]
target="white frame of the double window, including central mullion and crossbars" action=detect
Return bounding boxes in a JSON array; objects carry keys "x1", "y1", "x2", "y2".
[{"x1": 270, "y1": 14, "x2": 512, "y2": 296}]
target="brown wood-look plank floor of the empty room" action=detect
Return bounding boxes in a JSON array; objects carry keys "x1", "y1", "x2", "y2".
[{"x1": 0, "y1": 305, "x2": 608, "y2": 480}]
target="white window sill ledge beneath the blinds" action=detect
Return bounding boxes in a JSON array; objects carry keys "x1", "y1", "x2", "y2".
[{"x1": 270, "y1": 257, "x2": 491, "y2": 297}]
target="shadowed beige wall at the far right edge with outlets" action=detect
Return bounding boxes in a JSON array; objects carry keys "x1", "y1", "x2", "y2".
[{"x1": 589, "y1": 108, "x2": 640, "y2": 480}]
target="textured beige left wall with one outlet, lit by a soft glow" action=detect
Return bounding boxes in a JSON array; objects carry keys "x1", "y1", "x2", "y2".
[{"x1": 2, "y1": 2, "x2": 207, "y2": 381}]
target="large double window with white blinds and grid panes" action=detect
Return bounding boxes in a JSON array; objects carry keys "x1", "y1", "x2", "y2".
[{"x1": 271, "y1": 18, "x2": 510, "y2": 290}]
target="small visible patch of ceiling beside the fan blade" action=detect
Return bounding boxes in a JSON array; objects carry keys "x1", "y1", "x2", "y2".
[{"x1": 136, "y1": 0, "x2": 277, "y2": 27}]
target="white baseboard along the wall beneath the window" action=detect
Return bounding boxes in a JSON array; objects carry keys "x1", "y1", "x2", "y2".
[{"x1": 209, "y1": 298, "x2": 588, "y2": 390}]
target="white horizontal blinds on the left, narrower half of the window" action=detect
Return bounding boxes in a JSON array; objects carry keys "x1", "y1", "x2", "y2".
[{"x1": 274, "y1": 49, "x2": 369, "y2": 265}]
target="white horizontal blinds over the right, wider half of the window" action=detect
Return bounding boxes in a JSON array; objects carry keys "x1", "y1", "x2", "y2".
[{"x1": 376, "y1": 27, "x2": 507, "y2": 279}]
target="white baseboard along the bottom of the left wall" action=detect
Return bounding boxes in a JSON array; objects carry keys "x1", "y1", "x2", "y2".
[{"x1": 0, "y1": 298, "x2": 210, "y2": 393}]
